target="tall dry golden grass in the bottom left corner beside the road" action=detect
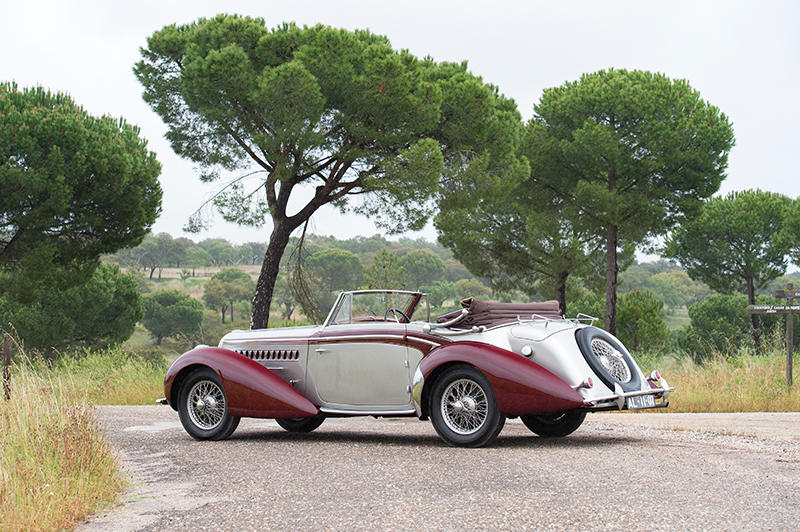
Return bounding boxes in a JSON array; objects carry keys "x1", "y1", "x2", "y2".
[{"x1": 0, "y1": 363, "x2": 124, "y2": 531}]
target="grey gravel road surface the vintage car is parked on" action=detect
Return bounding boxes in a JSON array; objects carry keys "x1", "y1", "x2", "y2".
[{"x1": 79, "y1": 406, "x2": 800, "y2": 531}]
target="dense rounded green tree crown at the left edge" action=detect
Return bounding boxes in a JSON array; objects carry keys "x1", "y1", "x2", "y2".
[{"x1": 0, "y1": 83, "x2": 161, "y2": 288}]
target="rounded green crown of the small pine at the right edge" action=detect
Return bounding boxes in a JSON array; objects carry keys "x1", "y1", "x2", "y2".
[{"x1": 666, "y1": 190, "x2": 797, "y2": 304}]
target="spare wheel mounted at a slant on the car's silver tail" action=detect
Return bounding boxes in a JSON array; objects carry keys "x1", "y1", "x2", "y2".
[{"x1": 575, "y1": 327, "x2": 642, "y2": 392}]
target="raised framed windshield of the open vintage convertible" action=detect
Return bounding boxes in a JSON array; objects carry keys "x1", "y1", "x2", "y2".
[{"x1": 330, "y1": 291, "x2": 420, "y2": 324}]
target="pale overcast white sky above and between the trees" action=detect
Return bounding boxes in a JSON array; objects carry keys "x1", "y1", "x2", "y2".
[{"x1": 0, "y1": 0, "x2": 800, "y2": 243}]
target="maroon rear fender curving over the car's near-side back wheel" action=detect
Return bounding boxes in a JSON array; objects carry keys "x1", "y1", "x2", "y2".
[{"x1": 414, "y1": 342, "x2": 584, "y2": 419}]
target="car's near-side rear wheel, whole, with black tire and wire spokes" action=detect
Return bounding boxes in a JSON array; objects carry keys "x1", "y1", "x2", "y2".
[{"x1": 430, "y1": 365, "x2": 506, "y2": 447}]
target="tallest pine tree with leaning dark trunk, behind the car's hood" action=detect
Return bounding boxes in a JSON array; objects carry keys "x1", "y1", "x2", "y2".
[{"x1": 134, "y1": 15, "x2": 520, "y2": 327}]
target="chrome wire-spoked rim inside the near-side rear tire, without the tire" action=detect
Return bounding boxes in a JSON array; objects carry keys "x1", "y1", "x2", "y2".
[{"x1": 440, "y1": 379, "x2": 489, "y2": 435}]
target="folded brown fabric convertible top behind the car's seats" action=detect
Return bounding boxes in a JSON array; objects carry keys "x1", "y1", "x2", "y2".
[{"x1": 436, "y1": 297, "x2": 561, "y2": 329}]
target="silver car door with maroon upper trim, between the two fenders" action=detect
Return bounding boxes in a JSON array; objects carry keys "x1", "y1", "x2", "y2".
[{"x1": 308, "y1": 322, "x2": 411, "y2": 411}]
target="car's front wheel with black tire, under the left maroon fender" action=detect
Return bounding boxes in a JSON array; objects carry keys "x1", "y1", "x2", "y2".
[{"x1": 178, "y1": 368, "x2": 239, "y2": 440}]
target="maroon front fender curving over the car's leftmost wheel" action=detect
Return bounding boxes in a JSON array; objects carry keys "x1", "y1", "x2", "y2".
[{"x1": 164, "y1": 346, "x2": 319, "y2": 418}]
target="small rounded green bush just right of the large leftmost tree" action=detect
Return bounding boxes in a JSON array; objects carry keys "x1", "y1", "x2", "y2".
[{"x1": 142, "y1": 290, "x2": 203, "y2": 345}]
